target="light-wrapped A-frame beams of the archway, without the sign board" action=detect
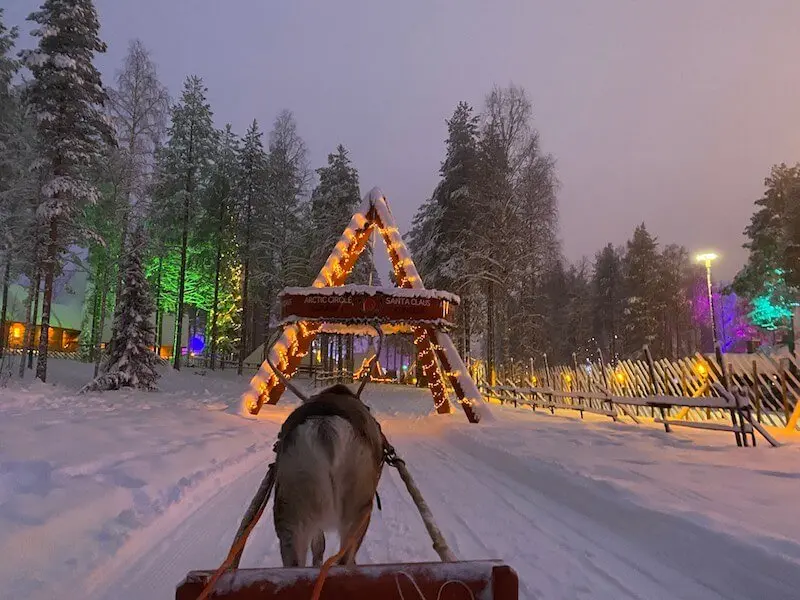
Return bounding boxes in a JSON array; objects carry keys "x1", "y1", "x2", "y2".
[{"x1": 243, "y1": 188, "x2": 491, "y2": 423}]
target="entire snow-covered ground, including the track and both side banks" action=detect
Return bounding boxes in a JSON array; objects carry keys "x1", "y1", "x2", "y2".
[{"x1": 0, "y1": 360, "x2": 800, "y2": 600}]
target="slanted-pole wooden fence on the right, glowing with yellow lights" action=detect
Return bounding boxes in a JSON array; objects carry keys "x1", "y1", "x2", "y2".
[{"x1": 472, "y1": 351, "x2": 800, "y2": 430}]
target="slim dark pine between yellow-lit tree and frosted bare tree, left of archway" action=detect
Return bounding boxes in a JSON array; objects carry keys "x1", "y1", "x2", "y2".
[{"x1": 236, "y1": 120, "x2": 274, "y2": 375}]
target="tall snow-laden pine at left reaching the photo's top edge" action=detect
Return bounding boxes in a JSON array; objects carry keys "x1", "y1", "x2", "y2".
[{"x1": 22, "y1": 0, "x2": 113, "y2": 381}]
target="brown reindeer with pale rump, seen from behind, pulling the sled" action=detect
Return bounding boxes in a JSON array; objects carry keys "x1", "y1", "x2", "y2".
[{"x1": 270, "y1": 328, "x2": 386, "y2": 567}]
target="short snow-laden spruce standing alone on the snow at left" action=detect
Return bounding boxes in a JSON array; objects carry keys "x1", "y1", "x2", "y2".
[{"x1": 81, "y1": 229, "x2": 160, "y2": 392}]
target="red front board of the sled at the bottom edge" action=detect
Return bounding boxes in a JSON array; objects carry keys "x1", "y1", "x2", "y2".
[{"x1": 175, "y1": 561, "x2": 519, "y2": 600}]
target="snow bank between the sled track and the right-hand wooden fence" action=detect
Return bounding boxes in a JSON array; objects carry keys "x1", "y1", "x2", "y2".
[{"x1": 415, "y1": 406, "x2": 800, "y2": 563}]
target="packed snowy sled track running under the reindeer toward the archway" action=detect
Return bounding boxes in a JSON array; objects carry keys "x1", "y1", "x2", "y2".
[{"x1": 76, "y1": 431, "x2": 800, "y2": 600}]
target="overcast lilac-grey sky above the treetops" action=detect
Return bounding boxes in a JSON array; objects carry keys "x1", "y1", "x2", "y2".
[{"x1": 3, "y1": 0, "x2": 800, "y2": 277}]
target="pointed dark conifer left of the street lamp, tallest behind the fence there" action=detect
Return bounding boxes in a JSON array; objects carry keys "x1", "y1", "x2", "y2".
[{"x1": 622, "y1": 223, "x2": 661, "y2": 356}]
